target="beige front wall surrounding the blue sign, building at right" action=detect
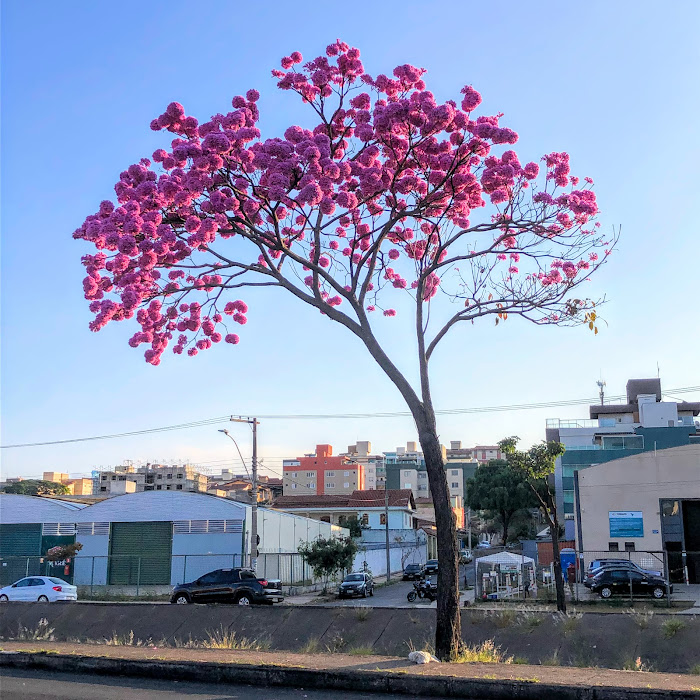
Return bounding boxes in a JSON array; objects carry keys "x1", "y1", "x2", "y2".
[{"x1": 578, "y1": 444, "x2": 700, "y2": 551}]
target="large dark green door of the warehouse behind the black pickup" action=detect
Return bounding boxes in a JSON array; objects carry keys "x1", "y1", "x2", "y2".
[{"x1": 108, "y1": 522, "x2": 173, "y2": 586}]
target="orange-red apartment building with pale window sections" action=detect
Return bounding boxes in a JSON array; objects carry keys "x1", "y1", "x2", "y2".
[{"x1": 282, "y1": 445, "x2": 365, "y2": 496}]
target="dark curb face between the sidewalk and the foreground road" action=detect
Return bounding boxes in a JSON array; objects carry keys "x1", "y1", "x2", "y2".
[{"x1": 0, "y1": 652, "x2": 700, "y2": 700}]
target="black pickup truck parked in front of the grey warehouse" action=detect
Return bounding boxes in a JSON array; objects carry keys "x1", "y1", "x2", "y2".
[{"x1": 170, "y1": 568, "x2": 284, "y2": 605}]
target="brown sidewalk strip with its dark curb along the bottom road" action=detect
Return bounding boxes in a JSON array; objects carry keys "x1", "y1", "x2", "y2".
[{"x1": 0, "y1": 642, "x2": 700, "y2": 700}]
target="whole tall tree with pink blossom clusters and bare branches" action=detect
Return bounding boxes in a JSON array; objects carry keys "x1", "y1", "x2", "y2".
[{"x1": 74, "y1": 41, "x2": 611, "y2": 658}]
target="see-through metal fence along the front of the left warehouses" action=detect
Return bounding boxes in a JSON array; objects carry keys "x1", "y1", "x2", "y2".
[{"x1": 0, "y1": 553, "x2": 332, "y2": 595}]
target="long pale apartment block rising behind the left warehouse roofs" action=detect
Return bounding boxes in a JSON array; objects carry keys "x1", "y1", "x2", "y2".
[{"x1": 97, "y1": 464, "x2": 207, "y2": 494}]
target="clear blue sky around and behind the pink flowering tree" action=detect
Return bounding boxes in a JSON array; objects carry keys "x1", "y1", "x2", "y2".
[{"x1": 1, "y1": 0, "x2": 700, "y2": 476}]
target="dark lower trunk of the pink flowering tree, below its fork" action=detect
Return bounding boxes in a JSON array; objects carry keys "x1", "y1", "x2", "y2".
[{"x1": 415, "y1": 415, "x2": 462, "y2": 661}]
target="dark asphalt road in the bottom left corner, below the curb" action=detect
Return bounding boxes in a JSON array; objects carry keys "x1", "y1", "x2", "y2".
[{"x1": 0, "y1": 668, "x2": 426, "y2": 700}]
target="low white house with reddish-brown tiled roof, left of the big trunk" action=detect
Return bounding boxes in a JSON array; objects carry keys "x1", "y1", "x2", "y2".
[{"x1": 274, "y1": 489, "x2": 416, "y2": 530}]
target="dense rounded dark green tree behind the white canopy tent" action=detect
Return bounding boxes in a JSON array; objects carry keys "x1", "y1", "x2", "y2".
[{"x1": 467, "y1": 459, "x2": 539, "y2": 545}]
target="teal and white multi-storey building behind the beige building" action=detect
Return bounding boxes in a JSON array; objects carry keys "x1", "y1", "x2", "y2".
[{"x1": 546, "y1": 378, "x2": 700, "y2": 540}]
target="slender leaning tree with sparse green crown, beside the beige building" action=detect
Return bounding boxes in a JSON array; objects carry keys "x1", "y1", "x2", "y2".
[{"x1": 498, "y1": 436, "x2": 566, "y2": 612}]
